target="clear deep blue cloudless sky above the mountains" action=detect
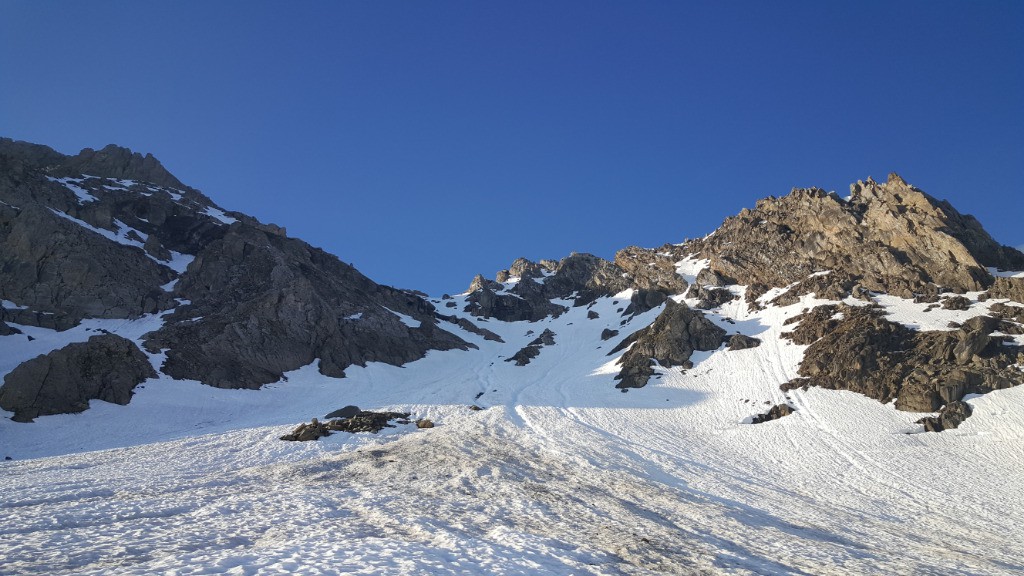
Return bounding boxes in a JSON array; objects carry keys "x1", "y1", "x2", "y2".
[{"x1": 0, "y1": 0, "x2": 1024, "y2": 294}]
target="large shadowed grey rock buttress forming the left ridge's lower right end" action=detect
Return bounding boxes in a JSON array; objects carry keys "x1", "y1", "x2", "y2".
[{"x1": 145, "y1": 222, "x2": 470, "y2": 388}]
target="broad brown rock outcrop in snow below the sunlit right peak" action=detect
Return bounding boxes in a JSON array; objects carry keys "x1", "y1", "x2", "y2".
[{"x1": 783, "y1": 305, "x2": 1024, "y2": 412}]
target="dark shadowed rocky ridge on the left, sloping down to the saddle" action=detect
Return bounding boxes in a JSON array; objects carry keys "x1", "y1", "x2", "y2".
[{"x1": 0, "y1": 138, "x2": 475, "y2": 418}]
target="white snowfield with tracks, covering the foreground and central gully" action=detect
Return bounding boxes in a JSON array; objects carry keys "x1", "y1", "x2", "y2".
[{"x1": 0, "y1": 276, "x2": 1024, "y2": 574}]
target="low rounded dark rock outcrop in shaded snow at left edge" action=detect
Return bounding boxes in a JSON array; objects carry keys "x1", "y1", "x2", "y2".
[{"x1": 0, "y1": 334, "x2": 157, "y2": 422}]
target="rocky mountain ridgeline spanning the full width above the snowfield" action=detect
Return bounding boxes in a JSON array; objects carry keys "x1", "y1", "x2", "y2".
[{"x1": 0, "y1": 139, "x2": 1024, "y2": 429}]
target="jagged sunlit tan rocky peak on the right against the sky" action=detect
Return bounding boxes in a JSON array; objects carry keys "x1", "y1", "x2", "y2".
[{"x1": 685, "y1": 174, "x2": 1024, "y2": 302}]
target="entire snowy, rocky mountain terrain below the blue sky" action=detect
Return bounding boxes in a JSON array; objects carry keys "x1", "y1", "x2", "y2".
[{"x1": 0, "y1": 136, "x2": 1024, "y2": 574}]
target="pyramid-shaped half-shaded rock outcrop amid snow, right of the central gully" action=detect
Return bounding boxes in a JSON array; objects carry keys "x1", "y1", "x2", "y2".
[{"x1": 611, "y1": 299, "x2": 726, "y2": 388}]
